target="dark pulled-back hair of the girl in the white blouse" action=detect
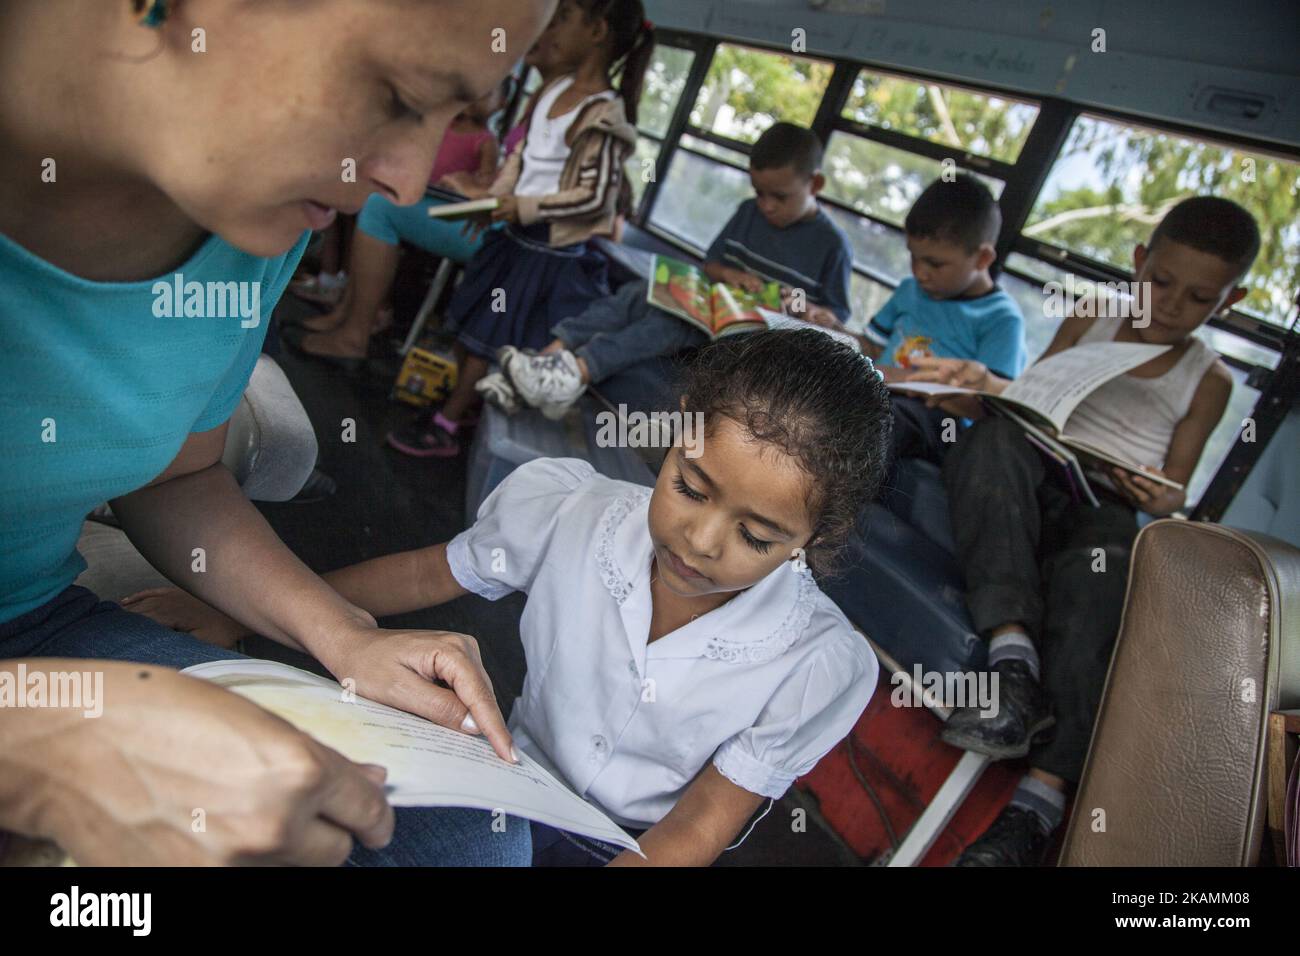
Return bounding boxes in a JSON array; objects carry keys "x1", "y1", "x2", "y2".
[{"x1": 681, "y1": 329, "x2": 893, "y2": 574}]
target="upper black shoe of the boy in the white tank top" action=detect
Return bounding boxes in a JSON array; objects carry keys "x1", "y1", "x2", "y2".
[{"x1": 940, "y1": 659, "x2": 1056, "y2": 760}]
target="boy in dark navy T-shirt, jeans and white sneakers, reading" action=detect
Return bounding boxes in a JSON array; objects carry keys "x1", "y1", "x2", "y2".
[{"x1": 480, "y1": 122, "x2": 853, "y2": 418}]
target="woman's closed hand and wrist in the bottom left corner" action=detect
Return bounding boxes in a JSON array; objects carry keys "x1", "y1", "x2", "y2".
[{"x1": 0, "y1": 659, "x2": 394, "y2": 866}]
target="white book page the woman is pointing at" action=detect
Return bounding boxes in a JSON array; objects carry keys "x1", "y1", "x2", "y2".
[{"x1": 182, "y1": 659, "x2": 644, "y2": 856}]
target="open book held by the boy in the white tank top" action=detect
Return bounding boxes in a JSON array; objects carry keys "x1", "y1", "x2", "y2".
[{"x1": 889, "y1": 342, "x2": 1183, "y2": 505}]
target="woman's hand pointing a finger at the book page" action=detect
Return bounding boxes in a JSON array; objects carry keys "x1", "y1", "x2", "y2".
[{"x1": 322, "y1": 626, "x2": 516, "y2": 763}]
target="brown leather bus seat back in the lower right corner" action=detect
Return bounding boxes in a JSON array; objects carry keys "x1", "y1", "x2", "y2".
[{"x1": 1061, "y1": 520, "x2": 1300, "y2": 866}]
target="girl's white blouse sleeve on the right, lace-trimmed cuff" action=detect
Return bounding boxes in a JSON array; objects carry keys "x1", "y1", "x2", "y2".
[{"x1": 714, "y1": 631, "x2": 879, "y2": 799}]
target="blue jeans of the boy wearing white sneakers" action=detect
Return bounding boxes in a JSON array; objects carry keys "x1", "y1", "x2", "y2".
[{"x1": 551, "y1": 281, "x2": 709, "y2": 384}]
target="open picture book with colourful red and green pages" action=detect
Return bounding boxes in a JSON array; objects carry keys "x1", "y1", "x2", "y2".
[{"x1": 646, "y1": 255, "x2": 784, "y2": 339}]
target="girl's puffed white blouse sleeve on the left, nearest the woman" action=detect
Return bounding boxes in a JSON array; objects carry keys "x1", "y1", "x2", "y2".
[{"x1": 447, "y1": 458, "x2": 595, "y2": 601}]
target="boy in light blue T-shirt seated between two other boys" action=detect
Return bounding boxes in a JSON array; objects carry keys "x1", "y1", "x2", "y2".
[{"x1": 858, "y1": 176, "x2": 1026, "y2": 463}]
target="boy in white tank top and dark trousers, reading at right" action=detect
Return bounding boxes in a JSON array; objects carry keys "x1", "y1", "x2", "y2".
[{"x1": 914, "y1": 196, "x2": 1260, "y2": 866}]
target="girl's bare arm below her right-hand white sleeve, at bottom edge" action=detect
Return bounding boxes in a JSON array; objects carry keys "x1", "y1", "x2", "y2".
[{"x1": 610, "y1": 763, "x2": 766, "y2": 866}]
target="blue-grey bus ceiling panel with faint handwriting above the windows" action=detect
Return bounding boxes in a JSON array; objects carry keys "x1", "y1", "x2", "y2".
[{"x1": 646, "y1": 0, "x2": 1300, "y2": 148}]
